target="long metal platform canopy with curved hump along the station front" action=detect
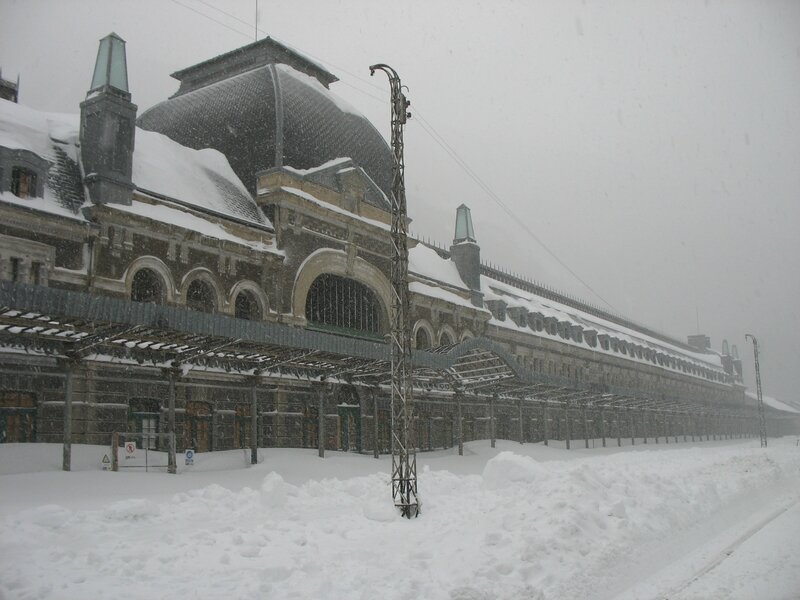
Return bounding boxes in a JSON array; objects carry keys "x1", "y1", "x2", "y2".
[{"x1": 0, "y1": 282, "x2": 744, "y2": 414}]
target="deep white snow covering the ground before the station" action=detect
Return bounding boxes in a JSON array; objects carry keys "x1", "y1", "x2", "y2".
[{"x1": 0, "y1": 438, "x2": 800, "y2": 600}]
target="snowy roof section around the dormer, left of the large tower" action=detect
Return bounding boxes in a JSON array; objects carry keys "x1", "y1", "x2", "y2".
[{"x1": 0, "y1": 101, "x2": 84, "y2": 220}]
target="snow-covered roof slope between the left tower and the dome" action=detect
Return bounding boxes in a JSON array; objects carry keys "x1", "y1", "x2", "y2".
[{"x1": 133, "y1": 127, "x2": 271, "y2": 226}]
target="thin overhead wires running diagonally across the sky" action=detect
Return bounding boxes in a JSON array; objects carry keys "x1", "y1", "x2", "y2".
[{"x1": 167, "y1": 0, "x2": 619, "y2": 312}]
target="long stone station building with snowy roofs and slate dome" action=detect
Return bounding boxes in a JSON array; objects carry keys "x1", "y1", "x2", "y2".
[{"x1": 0, "y1": 35, "x2": 792, "y2": 451}]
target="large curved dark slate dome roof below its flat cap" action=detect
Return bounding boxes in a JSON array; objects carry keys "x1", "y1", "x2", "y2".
[{"x1": 138, "y1": 58, "x2": 393, "y2": 195}]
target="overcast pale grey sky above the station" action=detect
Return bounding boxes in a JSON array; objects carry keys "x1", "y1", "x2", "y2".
[{"x1": 0, "y1": 0, "x2": 800, "y2": 400}]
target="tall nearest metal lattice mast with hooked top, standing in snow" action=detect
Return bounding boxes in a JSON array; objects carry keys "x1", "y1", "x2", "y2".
[{"x1": 369, "y1": 64, "x2": 419, "y2": 519}]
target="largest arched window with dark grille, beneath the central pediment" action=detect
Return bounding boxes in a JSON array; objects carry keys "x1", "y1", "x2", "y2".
[{"x1": 306, "y1": 273, "x2": 385, "y2": 334}]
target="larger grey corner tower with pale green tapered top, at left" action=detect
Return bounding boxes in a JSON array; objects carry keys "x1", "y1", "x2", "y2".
[{"x1": 80, "y1": 33, "x2": 136, "y2": 204}]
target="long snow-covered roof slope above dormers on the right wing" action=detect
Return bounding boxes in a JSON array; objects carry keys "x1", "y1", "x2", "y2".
[{"x1": 481, "y1": 275, "x2": 722, "y2": 371}]
